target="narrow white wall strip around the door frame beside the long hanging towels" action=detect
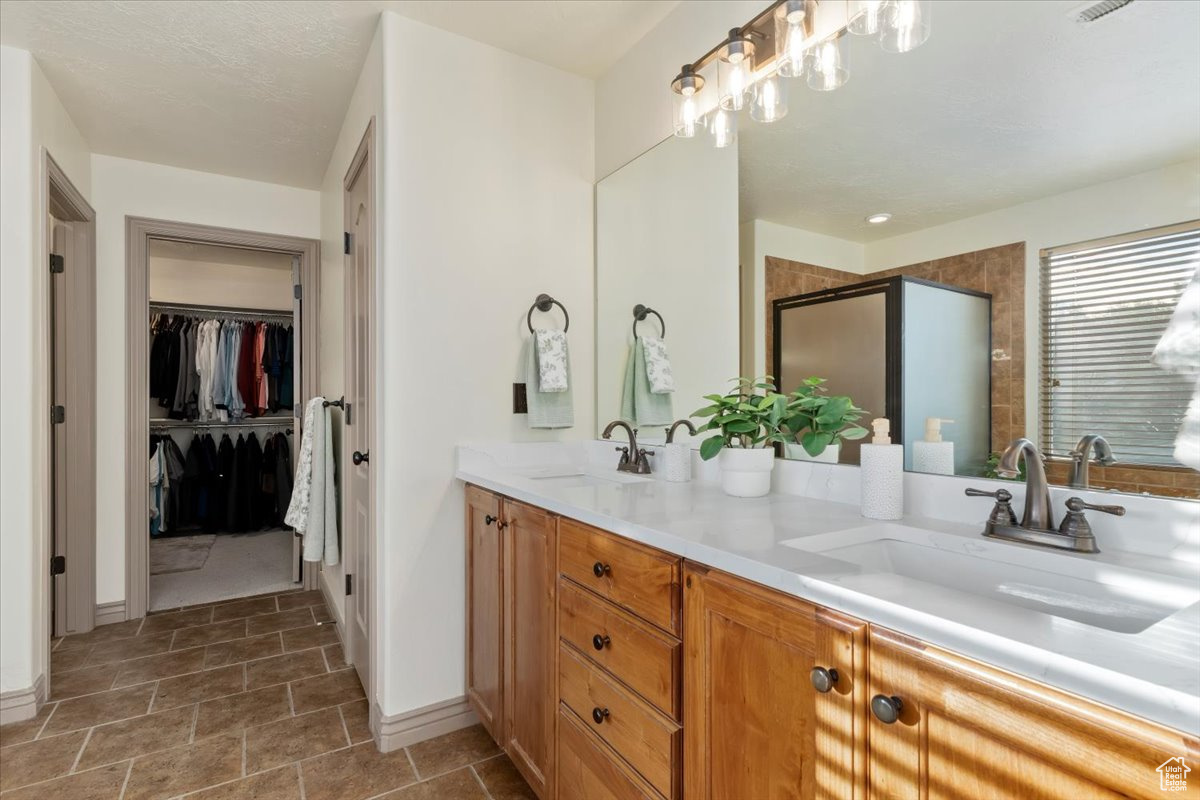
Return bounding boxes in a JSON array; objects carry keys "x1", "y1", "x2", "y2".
[{"x1": 318, "y1": 21, "x2": 383, "y2": 625}]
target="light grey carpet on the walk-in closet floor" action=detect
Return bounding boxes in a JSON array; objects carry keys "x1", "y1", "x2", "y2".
[{"x1": 150, "y1": 530, "x2": 296, "y2": 610}]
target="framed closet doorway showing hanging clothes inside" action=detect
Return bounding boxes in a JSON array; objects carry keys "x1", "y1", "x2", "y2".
[{"x1": 126, "y1": 217, "x2": 319, "y2": 619}]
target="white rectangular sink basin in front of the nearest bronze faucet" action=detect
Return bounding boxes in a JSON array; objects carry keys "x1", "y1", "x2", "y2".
[{"x1": 784, "y1": 524, "x2": 1200, "y2": 633}]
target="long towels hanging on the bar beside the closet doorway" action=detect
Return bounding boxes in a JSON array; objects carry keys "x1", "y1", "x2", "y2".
[{"x1": 283, "y1": 397, "x2": 341, "y2": 566}]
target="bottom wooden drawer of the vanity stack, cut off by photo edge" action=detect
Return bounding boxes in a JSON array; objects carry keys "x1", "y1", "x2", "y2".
[{"x1": 557, "y1": 706, "x2": 661, "y2": 800}]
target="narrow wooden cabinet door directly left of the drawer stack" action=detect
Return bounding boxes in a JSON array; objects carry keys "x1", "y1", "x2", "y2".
[{"x1": 504, "y1": 500, "x2": 557, "y2": 798}]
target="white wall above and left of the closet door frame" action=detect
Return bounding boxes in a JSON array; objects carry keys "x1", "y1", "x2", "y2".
[{"x1": 91, "y1": 155, "x2": 320, "y2": 603}]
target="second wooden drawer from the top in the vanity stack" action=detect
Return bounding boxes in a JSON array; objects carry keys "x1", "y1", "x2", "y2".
[{"x1": 558, "y1": 578, "x2": 679, "y2": 720}]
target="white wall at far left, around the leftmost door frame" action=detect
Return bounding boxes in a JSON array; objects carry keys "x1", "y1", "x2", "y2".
[{"x1": 0, "y1": 47, "x2": 91, "y2": 692}]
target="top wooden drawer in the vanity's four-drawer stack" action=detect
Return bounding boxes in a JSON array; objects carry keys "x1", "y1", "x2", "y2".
[{"x1": 558, "y1": 519, "x2": 679, "y2": 634}]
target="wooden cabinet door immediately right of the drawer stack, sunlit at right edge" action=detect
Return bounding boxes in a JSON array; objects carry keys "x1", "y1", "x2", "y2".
[{"x1": 683, "y1": 564, "x2": 866, "y2": 800}]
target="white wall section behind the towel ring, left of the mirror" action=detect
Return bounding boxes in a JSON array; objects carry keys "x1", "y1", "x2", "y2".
[{"x1": 371, "y1": 12, "x2": 595, "y2": 715}]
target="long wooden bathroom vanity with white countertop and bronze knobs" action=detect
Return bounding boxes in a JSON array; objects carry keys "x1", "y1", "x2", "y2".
[{"x1": 458, "y1": 453, "x2": 1200, "y2": 799}]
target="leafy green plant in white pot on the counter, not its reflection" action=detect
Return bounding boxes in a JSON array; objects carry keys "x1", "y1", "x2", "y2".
[{"x1": 692, "y1": 375, "x2": 790, "y2": 498}]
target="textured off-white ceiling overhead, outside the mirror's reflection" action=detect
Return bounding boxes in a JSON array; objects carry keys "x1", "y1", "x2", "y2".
[{"x1": 0, "y1": 0, "x2": 679, "y2": 188}]
